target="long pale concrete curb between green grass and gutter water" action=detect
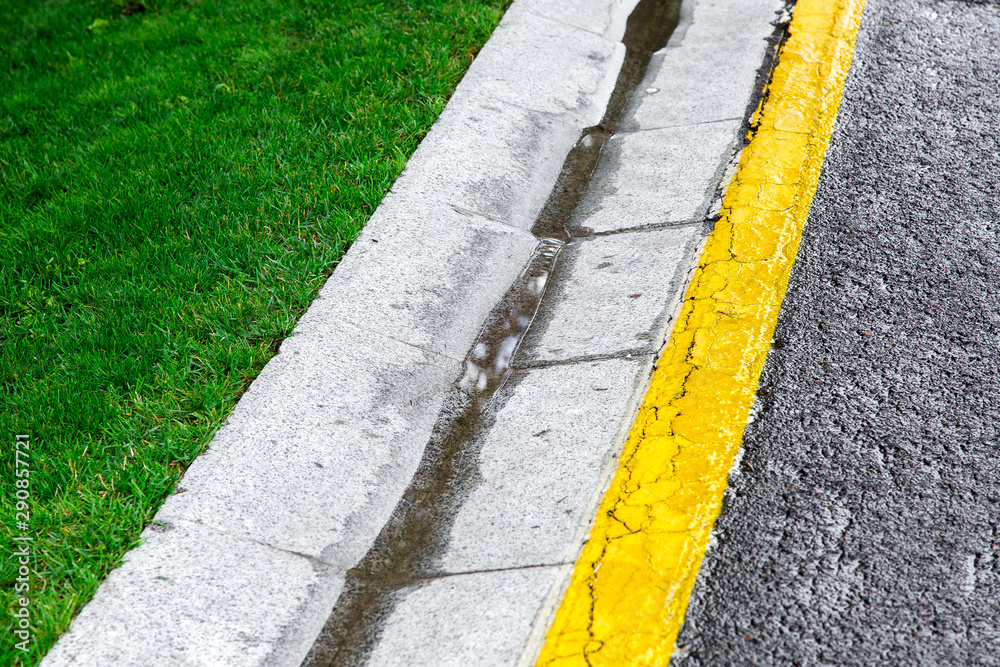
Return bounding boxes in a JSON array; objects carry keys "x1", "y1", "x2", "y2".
[{"x1": 43, "y1": 0, "x2": 634, "y2": 666}]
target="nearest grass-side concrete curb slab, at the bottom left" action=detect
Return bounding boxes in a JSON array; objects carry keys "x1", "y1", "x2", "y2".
[{"x1": 39, "y1": 521, "x2": 343, "y2": 667}]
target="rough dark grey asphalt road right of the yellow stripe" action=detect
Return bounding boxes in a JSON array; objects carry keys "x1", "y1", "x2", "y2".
[{"x1": 674, "y1": 0, "x2": 1000, "y2": 666}]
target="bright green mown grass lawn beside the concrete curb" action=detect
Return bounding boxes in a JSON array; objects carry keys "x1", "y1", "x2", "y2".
[{"x1": 0, "y1": 0, "x2": 507, "y2": 665}]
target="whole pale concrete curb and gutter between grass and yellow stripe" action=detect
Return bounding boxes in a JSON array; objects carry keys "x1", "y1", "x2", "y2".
[{"x1": 44, "y1": 0, "x2": 785, "y2": 666}]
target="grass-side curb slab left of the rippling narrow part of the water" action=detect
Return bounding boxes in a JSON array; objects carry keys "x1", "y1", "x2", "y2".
[{"x1": 290, "y1": 194, "x2": 537, "y2": 360}]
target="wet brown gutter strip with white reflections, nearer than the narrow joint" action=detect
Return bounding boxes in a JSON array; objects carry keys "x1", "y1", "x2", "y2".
[{"x1": 302, "y1": 239, "x2": 563, "y2": 667}]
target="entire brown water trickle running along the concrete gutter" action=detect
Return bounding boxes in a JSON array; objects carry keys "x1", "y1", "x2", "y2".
[{"x1": 302, "y1": 0, "x2": 680, "y2": 667}]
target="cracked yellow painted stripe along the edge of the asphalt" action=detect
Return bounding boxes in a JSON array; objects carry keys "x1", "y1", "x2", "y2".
[{"x1": 537, "y1": 0, "x2": 864, "y2": 667}]
